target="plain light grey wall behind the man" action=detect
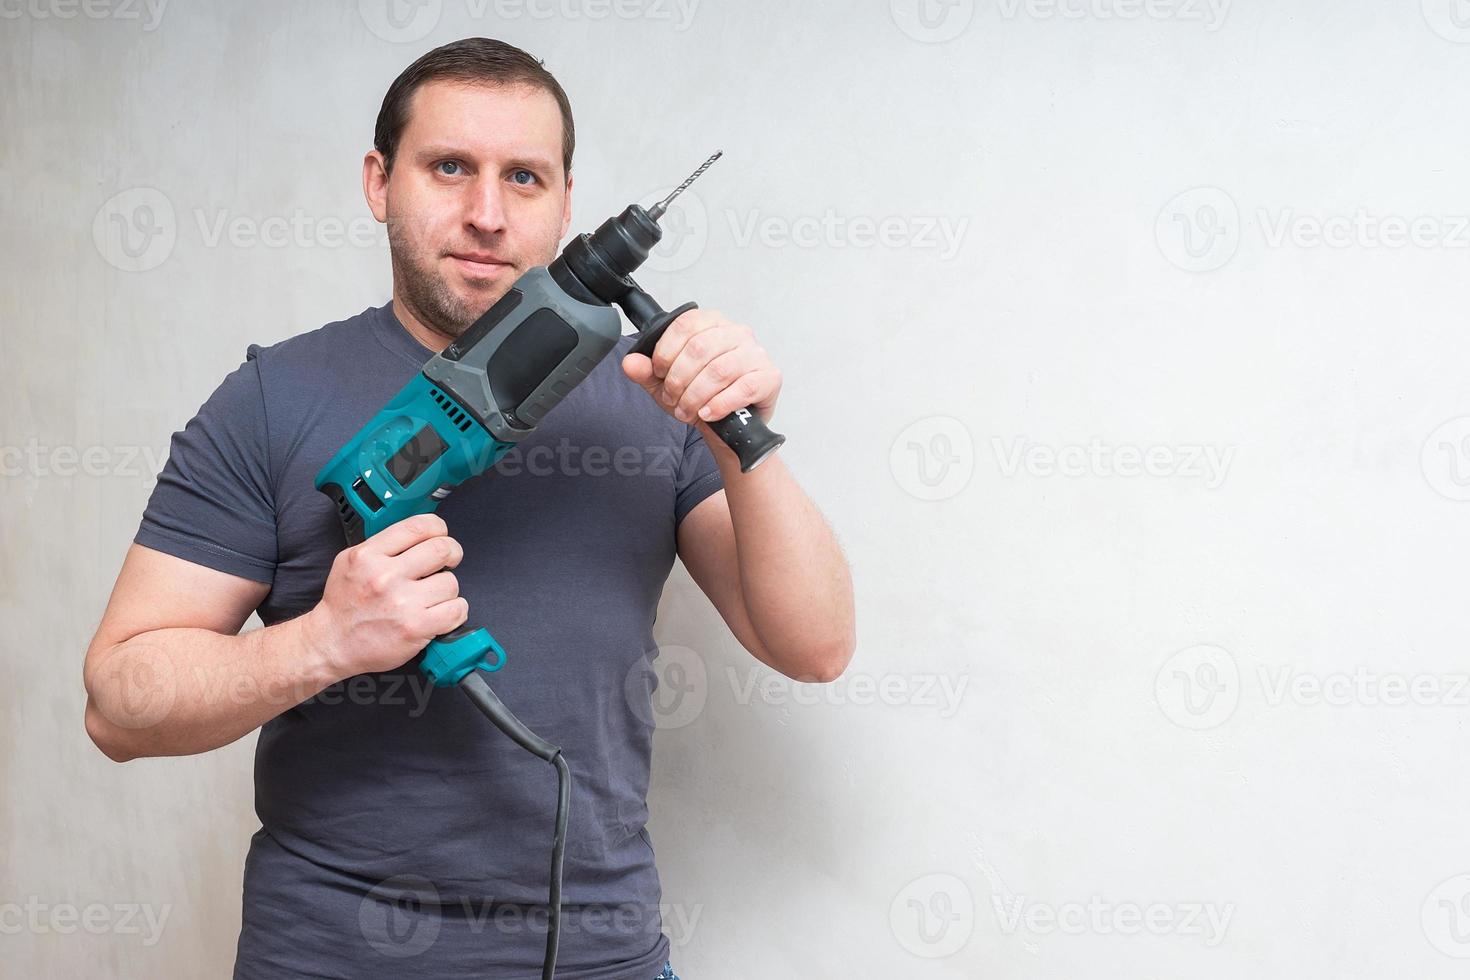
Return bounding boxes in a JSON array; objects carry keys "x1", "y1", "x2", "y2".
[{"x1": 0, "y1": 0, "x2": 1470, "y2": 980}]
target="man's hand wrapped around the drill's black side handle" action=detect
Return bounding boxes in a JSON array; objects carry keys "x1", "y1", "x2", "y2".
[{"x1": 623, "y1": 310, "x2": 781, "y2": 432}]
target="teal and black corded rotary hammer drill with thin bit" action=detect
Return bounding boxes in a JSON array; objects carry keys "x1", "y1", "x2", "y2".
[{"x1": 315, "y1": 153, "x2": 785, "y2": 980}]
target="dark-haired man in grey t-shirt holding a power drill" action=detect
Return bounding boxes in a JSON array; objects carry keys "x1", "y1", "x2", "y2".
[{"x1": 85, "y1": 38, "x2": 854, "y2": 980}]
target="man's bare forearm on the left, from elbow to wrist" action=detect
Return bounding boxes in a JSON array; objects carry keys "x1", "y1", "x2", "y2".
[{"x1": 85, "y1": 613, "x2": 341, "y2": 763}]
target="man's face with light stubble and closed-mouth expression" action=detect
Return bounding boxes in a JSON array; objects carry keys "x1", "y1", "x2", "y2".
[{"x1": 363, "y1": 81, "x2": 572, "y2": 336}]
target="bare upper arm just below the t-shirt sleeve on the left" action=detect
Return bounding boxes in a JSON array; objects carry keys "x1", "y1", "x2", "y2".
[{"x1": 87, "y1": 544, "x2": 270, "y2": 667}]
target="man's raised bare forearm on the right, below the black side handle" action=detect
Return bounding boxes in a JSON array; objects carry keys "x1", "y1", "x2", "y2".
[{"x1": 711, "y1": 445, "x2": 856, "y2": 680}]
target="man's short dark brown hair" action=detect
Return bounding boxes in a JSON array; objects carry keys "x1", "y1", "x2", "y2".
[{"x1": 372, "y1": 37, "x2": 576, "y2": 182}]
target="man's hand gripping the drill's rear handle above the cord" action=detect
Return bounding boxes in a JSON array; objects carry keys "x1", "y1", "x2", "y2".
[{"x1": 303, "y1": 514, "x2": 469, "y2": 677}]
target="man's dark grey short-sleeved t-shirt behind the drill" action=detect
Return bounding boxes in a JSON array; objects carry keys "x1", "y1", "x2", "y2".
[{"x1": 135, "y1": 304, "x2": 722, "y2": 980}]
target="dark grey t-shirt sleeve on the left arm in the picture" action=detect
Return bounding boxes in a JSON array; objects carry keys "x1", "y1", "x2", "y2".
[{"x1": 134, "y1": 344, "x2": 276, "y2": 583}]
